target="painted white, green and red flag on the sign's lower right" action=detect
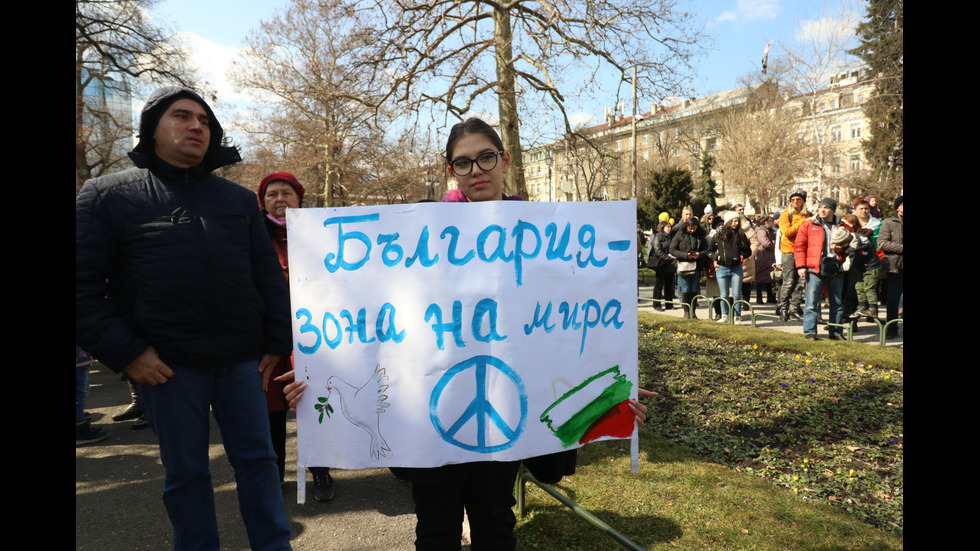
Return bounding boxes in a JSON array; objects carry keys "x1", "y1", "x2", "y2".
[{"x1": 541, "y1": 365, "x2": 634, "y2": 448}]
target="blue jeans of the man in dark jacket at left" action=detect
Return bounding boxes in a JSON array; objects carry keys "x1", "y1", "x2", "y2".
[{"x1": 139, "y1": 360, "x2": 290, "y2": 550}]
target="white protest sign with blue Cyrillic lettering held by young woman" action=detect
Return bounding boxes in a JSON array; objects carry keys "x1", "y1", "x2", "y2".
[{"x1": 286, "y1": 201, "x2": 637, "y2": 492}]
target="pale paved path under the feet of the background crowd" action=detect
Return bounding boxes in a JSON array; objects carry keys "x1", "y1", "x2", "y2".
[{"x1": 638, "y1": 285, "x2": 905, "y2": 348}]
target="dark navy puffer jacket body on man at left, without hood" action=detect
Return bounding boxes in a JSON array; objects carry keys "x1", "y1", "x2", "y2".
[{"x1": 75, "y1": 154, "x2": 292, "y2": 372}]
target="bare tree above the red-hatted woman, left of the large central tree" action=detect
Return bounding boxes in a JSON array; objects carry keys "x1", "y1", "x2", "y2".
[{"x1": 229, "y1": 0, "x2": 408, "y2": 206}]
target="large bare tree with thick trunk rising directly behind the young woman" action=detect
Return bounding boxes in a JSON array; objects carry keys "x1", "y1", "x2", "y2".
[{"x1": 361, "y1": 0, "x2": 701, "y2": 196}]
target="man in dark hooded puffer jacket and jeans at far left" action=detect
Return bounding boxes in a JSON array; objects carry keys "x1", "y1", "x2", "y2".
[{"x1": 75, "y1": 87, "x2": 292, "y2": 549}]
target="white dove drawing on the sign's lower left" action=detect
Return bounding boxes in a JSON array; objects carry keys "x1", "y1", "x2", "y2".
[{"x1": 327, "y1": 364, "x2": 391, "y2": 459}]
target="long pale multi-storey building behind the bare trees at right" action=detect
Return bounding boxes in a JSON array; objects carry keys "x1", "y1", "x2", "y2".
[{"x1": 524, "y1": 70, "x2": 874, "y2": 216}]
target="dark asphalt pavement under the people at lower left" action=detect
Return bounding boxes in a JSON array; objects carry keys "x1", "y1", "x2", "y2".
[{"x1": 75, "y1": 362, "x2": 415, "y2": 551}]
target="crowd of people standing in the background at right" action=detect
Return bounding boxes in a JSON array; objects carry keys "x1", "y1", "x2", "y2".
[{"x1": 646, "y1": 189, "x2": 904, "y2": 340}]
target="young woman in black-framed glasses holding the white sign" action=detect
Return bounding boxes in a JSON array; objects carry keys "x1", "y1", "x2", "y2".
[{"x1": 280, "y1": 118, "x2": 655, "y2": 551}]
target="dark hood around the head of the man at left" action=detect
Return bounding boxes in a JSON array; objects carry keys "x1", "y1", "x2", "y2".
[{"x1": 129, "y1": 86, "x2": 242, "y2": 172}]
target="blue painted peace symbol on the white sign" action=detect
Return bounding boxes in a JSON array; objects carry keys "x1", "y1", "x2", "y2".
[{"x1": 429, "y1": 356, "x2": 527, "y2": 453}]
